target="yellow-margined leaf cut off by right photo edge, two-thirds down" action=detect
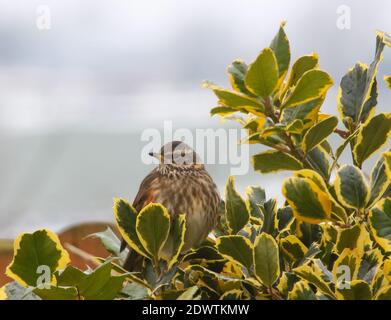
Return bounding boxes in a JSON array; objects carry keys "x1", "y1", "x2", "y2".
[{"x1": 369, "y1": 198, "x2": 391, "y2": 252}]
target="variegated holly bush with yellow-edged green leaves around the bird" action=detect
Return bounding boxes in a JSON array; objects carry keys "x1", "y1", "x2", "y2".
[{"x1": 0, "y1": 24, "x2": 391, "y2": 300}]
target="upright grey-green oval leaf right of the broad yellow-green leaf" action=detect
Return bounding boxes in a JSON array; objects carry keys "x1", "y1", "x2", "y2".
[{"x1": 334, "y1": 165, "x2": 369, "y2": 209}]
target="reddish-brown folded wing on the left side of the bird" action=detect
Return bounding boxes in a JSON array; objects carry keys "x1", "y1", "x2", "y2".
[{"x1": 120, "y1": 169, "x2": 160, "y2": 251}]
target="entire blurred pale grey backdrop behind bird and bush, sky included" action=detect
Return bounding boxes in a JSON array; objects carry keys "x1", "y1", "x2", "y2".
[{"x1": 0, "y1": 0, "x2": 391, "y2": 238}]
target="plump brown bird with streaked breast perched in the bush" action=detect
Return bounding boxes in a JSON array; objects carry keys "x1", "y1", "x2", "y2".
[{"x1": 120, "y1": 141, "x2": 222, "y2": 271}]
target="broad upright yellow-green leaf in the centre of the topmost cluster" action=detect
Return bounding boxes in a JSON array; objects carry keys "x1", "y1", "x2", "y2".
[{"x1": 245, "y1": 48, "x2": 279, "y2": 98}]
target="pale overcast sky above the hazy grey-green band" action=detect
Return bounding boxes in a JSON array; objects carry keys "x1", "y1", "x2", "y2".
[{"x1": 0, "y1": 0, "x2": 391, "y2": 131}]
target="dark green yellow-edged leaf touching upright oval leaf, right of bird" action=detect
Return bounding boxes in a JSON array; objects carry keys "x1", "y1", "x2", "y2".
[{"x1": 216, "y1": 235, "x2": 253, "y2": 270}]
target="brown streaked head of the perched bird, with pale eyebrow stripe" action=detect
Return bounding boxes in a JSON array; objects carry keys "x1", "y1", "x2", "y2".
[{"x1": 149, "y1": 141, "x2": 202, "y2": 167}]
